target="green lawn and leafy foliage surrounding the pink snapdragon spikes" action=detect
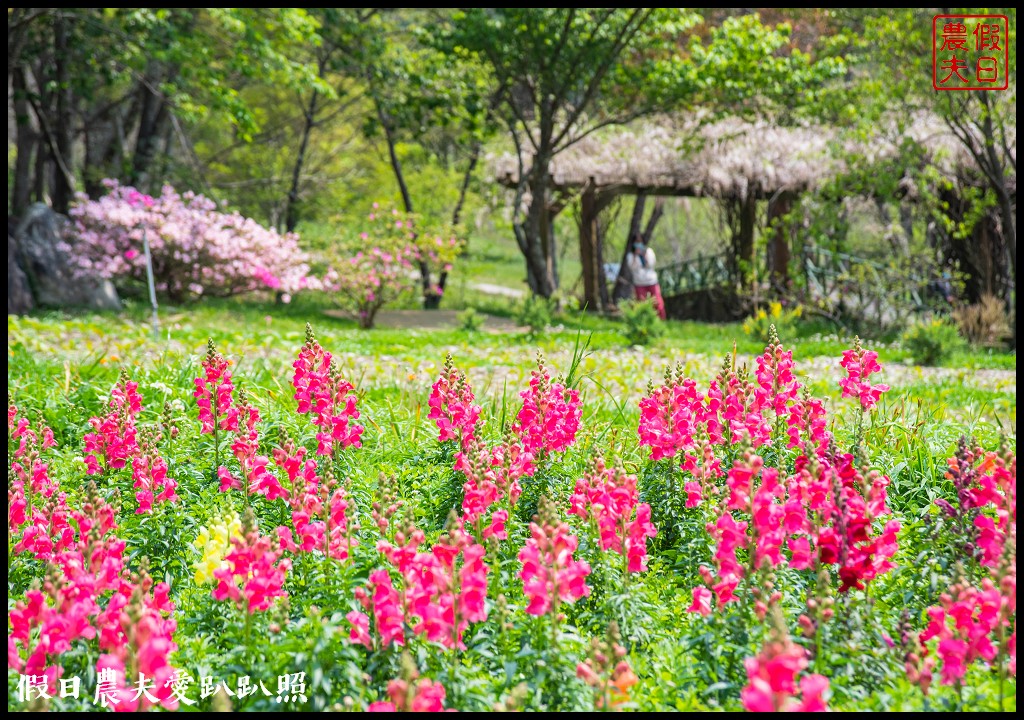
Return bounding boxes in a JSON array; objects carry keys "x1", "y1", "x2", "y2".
[{"x1": 7, "y1": 297, "x2": 1017, "y2": 711}]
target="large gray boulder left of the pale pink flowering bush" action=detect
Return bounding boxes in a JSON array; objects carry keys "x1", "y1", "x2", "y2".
[{"x1": 14, "y1": 203, "x2": 121, "y2": 310}]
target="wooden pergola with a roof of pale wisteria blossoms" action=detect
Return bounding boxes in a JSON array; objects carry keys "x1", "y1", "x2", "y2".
[{"x1": 490, "y1": 115, "x2": 999, "y2": 309}]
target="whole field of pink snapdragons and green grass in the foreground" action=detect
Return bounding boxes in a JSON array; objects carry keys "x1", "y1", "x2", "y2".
[{"x1": 8, "y1": 316, "x2": 1016, "y2": 712}]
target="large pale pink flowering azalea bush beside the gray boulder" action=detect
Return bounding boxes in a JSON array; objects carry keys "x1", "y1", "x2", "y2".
[{"x1": 62, "y1": 180, "x2": 317, "y2": 302}]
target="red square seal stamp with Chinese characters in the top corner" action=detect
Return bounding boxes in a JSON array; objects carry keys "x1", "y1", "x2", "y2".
[{"x1": 932, "y1": 15, "x2": 1010, "y2": 90}]
